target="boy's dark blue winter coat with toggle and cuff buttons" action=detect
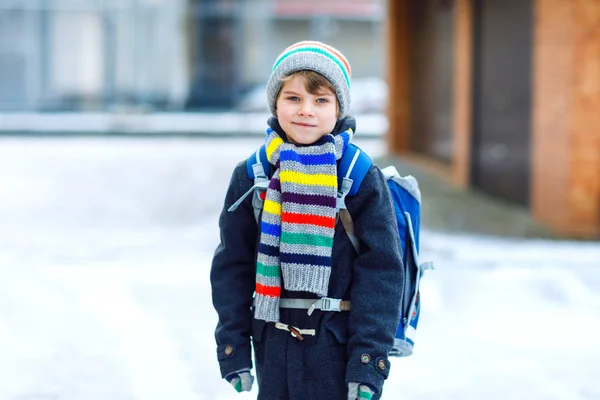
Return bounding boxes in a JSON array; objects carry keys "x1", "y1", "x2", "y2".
[{"x1": 211, "y1": 117, "x2": 404, "y2": 400}]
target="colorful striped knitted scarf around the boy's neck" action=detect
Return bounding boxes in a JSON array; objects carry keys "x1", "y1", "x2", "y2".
[{"x1": 254, "y1": 128, "x2": 353, "y2": 322}]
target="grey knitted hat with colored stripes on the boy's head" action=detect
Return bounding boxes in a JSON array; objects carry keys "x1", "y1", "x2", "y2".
[{"x1": 267, "y1": 41, "x2": 352, "y2": 118}]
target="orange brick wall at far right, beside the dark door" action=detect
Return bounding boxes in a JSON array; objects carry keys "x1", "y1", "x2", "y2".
[{"x1": 532, "y1": 0, "x2": 600, "y2": 237}]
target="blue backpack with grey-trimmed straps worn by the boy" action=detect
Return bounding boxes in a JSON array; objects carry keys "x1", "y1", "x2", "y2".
[{"x1": 229, "y1": 143, "x2": 433, "y2": 357}]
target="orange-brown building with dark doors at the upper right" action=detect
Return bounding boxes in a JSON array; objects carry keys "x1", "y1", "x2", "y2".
[{"x1": 388, "y1": 0, "x2": 600, "y2": 238}]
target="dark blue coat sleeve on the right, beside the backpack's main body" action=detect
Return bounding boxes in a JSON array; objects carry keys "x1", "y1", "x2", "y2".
[{"x1": 346, "y1": 166, "x2": 404, "y2": 392}]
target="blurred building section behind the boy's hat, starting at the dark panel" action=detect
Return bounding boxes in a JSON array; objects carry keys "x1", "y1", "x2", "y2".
[{"x1": 188, "y1": 0, "x2": 385, "y2": 109}]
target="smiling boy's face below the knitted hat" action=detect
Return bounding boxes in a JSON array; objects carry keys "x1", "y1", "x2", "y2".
[{"x1": 276, "y1": 75, "x2": 338, "y2": 144}]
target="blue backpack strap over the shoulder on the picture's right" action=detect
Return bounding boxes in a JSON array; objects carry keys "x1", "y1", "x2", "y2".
[{"x1": 336, "y1": 143, "x2": 373, "y2": 253}]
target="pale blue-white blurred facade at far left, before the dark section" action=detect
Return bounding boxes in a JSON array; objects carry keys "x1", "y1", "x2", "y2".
[{"x1": 0, "y1": 0, "x2": 188, "y2": 110}]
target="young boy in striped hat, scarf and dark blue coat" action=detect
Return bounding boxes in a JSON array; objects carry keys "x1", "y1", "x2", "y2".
[{"x1": 211, "y1": 41, "x2": 403, "y2": 400}]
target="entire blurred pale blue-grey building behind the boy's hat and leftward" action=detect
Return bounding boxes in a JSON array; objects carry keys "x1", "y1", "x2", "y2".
[{"x1": 0, "y1": 0, "x2": 385, "y2": 111}]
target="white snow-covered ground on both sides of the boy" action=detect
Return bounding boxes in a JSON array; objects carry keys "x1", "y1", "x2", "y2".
[{"x1": 0, "y1": 138, "x2": 600, "y2": 400}]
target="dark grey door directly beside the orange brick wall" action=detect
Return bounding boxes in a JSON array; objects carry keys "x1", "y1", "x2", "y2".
[{"x1": 471, "y1": 0, "x2": 533, "y2": 206}]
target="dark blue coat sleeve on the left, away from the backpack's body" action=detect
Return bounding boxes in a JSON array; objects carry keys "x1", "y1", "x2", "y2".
[{"x1": 210, "y1": 163, "x2": 258, "y2": 377}]
